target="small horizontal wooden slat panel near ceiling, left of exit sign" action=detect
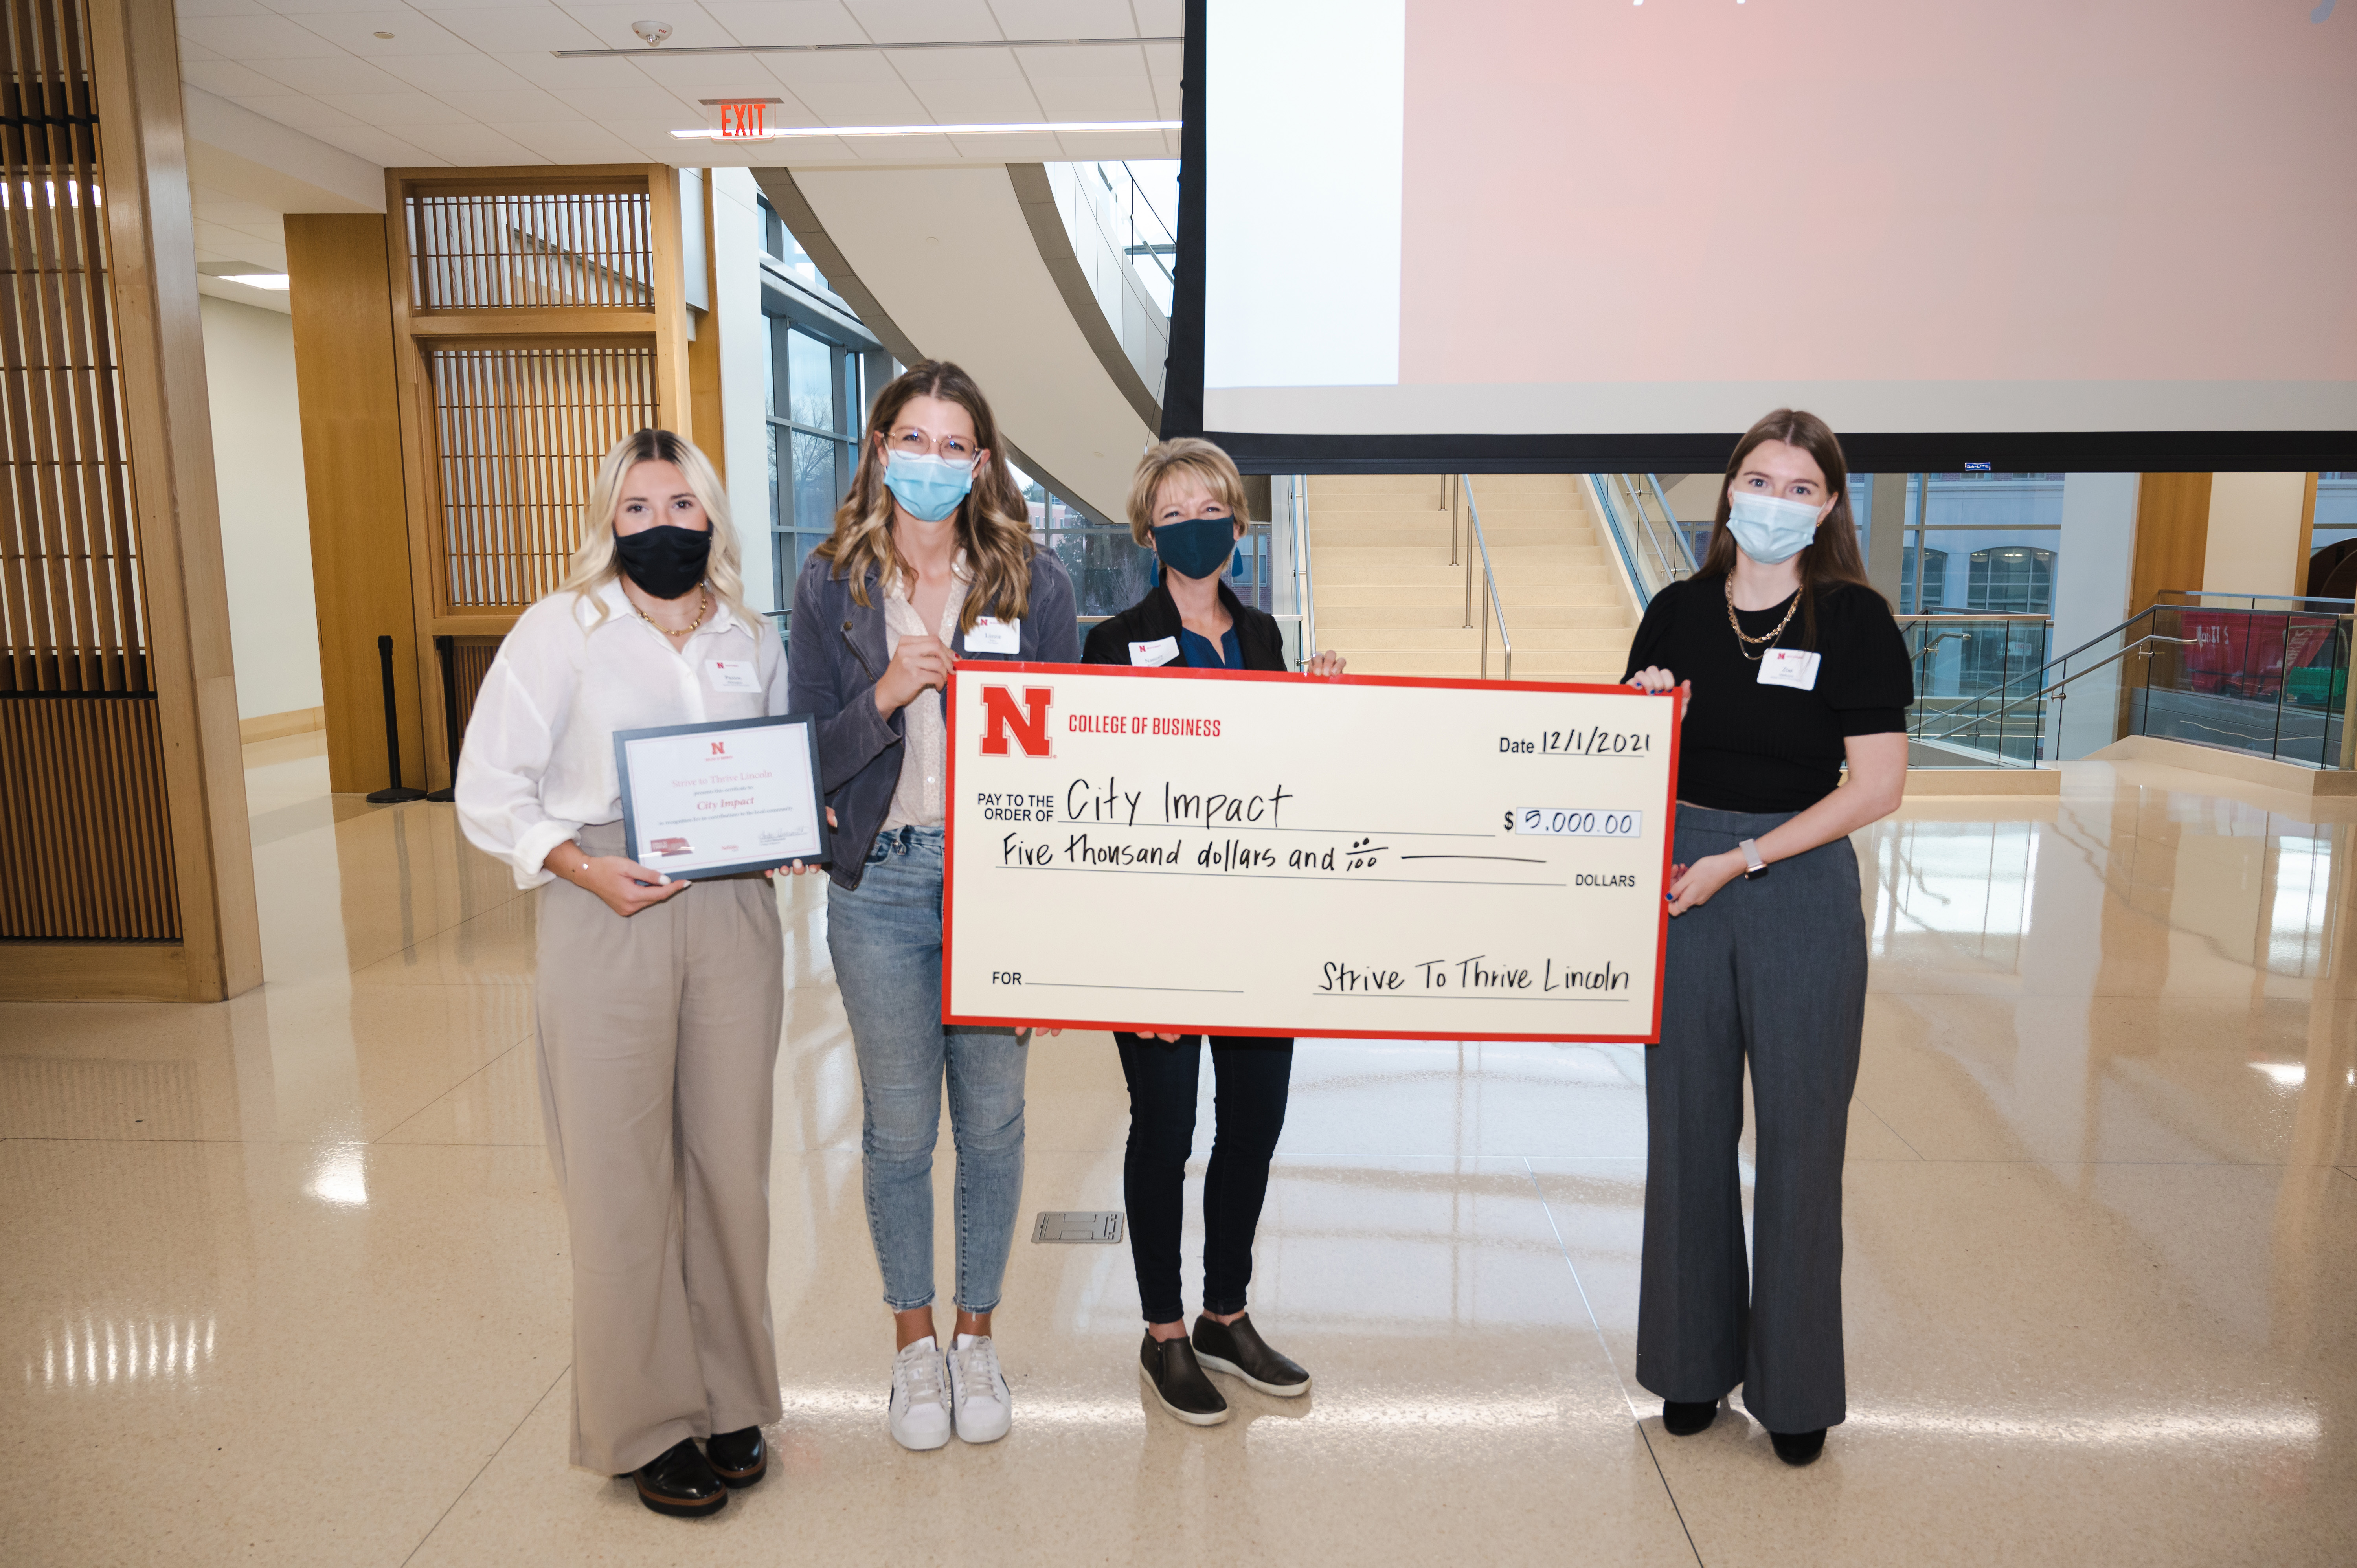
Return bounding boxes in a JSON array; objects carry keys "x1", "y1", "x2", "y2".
[{"x1": 405, "y1": 184, "x2": 655, "y2": 311}]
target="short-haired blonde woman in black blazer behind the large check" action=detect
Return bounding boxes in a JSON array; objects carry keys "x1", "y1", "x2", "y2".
[{"x1": 1082, "y1": 436, "x2": 1343, "y2": 1427}]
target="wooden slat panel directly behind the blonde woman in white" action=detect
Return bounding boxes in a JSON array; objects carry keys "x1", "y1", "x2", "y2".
[{"x1": 426, "y1": 340, "x2": 655, "y2": 611}]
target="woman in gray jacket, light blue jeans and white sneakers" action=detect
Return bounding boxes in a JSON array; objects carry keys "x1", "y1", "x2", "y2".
[{"x1": 787, "y1": 361, "x2": 1080, "y2": 1450}]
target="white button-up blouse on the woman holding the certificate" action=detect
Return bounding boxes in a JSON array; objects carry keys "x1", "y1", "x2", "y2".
[{"x1": 455, "y1": 582, "x2": 785, "y2": 887}]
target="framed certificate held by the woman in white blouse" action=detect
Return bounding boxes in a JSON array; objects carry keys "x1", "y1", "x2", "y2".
[{"x1": 613, "y1": 712, "x2": 832, "y2": 882}]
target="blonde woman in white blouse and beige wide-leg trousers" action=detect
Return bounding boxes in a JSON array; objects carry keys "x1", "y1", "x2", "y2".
[{"x1": 457, "y1": 429, "x2": 804, "y2": 1516}]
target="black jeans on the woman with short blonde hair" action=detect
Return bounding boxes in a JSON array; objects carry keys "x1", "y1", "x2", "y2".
[{"x1": 1113, "y1": 1033, "x2": 1294, "y2": 1323}]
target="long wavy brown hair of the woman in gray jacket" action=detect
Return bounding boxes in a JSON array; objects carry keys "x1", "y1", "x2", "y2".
[{"x1": 813, "y1": 358, "x2": 1035, "y2": 632}]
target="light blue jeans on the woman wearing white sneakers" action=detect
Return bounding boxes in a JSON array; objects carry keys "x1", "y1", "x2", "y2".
[{"x1": 827, "y1": 828, "x2": 1028, "y2": 1313}]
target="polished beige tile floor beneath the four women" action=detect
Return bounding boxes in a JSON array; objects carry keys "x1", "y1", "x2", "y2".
[{"x1": 0, "y1": 738, "x2": 2357, "y2": 1568}]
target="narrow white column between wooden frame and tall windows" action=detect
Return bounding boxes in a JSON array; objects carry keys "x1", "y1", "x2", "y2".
[{"x1": 702, "y1": 170, "x2": 773, "y2": 611}]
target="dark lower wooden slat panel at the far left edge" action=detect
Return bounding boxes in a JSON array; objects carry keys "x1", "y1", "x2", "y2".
[{"x1": 0, "y1": 696, "x2": 179, "y2": 941}]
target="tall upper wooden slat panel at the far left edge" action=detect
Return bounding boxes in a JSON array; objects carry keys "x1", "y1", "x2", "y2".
[{"x1": 0, "y1": 0, "x2": 153, "y2": 691}]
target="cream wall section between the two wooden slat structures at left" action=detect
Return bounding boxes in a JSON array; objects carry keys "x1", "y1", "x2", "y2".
[{"x1": 198, "y1": 297, "x2": 321, "y2": 719}]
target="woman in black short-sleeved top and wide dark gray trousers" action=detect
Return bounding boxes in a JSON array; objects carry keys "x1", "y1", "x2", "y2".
[{"x1": 1626, "y1": 408, "x2": 1914, "y2": 1464}]
